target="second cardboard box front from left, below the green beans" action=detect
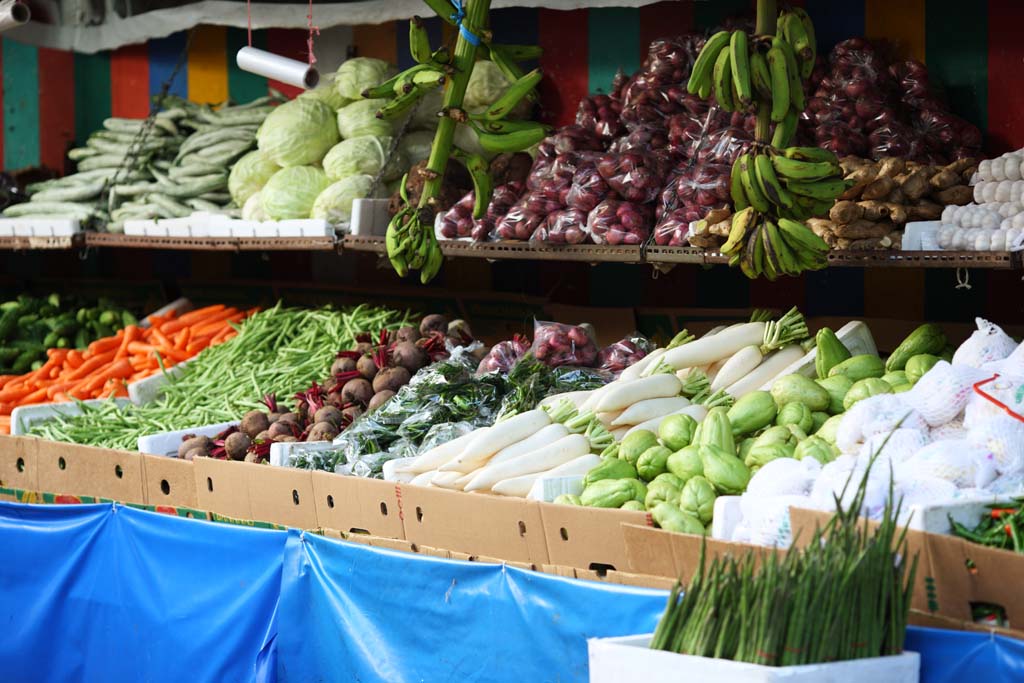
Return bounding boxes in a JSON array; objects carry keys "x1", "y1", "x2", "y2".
[{"x1": 37, "y1": 439, "x2": 145, "y2": 503}]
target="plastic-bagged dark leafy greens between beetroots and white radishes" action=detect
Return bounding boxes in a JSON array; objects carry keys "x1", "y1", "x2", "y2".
[{"x1": 292, "y1": 356, "x2": 606, "y2": 476}]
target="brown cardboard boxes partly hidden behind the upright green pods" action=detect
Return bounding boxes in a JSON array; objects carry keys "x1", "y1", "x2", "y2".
[{"x1": 623, "y1": 508, "x2": 1024, "y2": 639}]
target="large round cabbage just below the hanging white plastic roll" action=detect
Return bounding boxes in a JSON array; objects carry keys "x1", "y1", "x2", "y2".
[{"x1": 256, "y1": 98, "x2": 338, "y2": 167}]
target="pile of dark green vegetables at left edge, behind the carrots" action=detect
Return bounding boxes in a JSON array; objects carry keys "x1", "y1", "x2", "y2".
[{"x1": 0, "y1": 294, "x2": 138, "y2": 375}]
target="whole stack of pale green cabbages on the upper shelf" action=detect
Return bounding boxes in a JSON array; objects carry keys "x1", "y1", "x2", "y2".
[{"x1": 241, "y1": 57, "x2": 520, "y2": 226}]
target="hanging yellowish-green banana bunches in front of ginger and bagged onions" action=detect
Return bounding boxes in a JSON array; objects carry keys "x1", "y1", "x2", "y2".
[{"x1": 686, "y1": 7, "x2": 848, "y2": 280}]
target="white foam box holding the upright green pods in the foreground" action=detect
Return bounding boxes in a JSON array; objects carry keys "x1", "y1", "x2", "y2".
[{"x1": 587, "y1": 634, "x2": 921, "y2": 683}]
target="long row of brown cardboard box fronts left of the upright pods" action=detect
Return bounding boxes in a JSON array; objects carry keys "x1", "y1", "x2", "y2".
[{"x1": 0, "y1": 436, "x2": 651, "y2": 573}]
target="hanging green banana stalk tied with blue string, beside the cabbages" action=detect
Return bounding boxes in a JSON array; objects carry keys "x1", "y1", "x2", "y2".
[{"x1": 362, "y1": 0, "x2": 549, "y2": 284}]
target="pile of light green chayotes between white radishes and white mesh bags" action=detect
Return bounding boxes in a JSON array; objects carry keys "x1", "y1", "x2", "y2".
[{"x1": 555, "y1": 325, "x2": 952, "y2": 533}]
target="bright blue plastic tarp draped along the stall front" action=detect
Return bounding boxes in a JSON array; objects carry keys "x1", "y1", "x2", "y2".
[{"x1": 0, "y1": 503, "x2": 1024, "y2": 683}]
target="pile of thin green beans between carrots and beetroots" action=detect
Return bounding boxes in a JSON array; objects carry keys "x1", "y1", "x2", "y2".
[{"x1": 32, "y1": 303, "x2": 411, "y2": 450}]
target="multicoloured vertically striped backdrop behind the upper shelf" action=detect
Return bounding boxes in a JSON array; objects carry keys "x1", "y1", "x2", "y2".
[{"x1": 0, "y1": 0, "x2": 1024, "y2": 169}]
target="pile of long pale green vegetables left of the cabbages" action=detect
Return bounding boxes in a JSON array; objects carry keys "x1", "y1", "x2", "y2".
[{"x1": 3, "y1": 93, "x2": 284, "y2": 232}]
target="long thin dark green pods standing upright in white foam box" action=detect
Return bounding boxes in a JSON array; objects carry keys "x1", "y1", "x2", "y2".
[{"x1": 650, "y1": 444, "x2": 918, "y2": 667}]
